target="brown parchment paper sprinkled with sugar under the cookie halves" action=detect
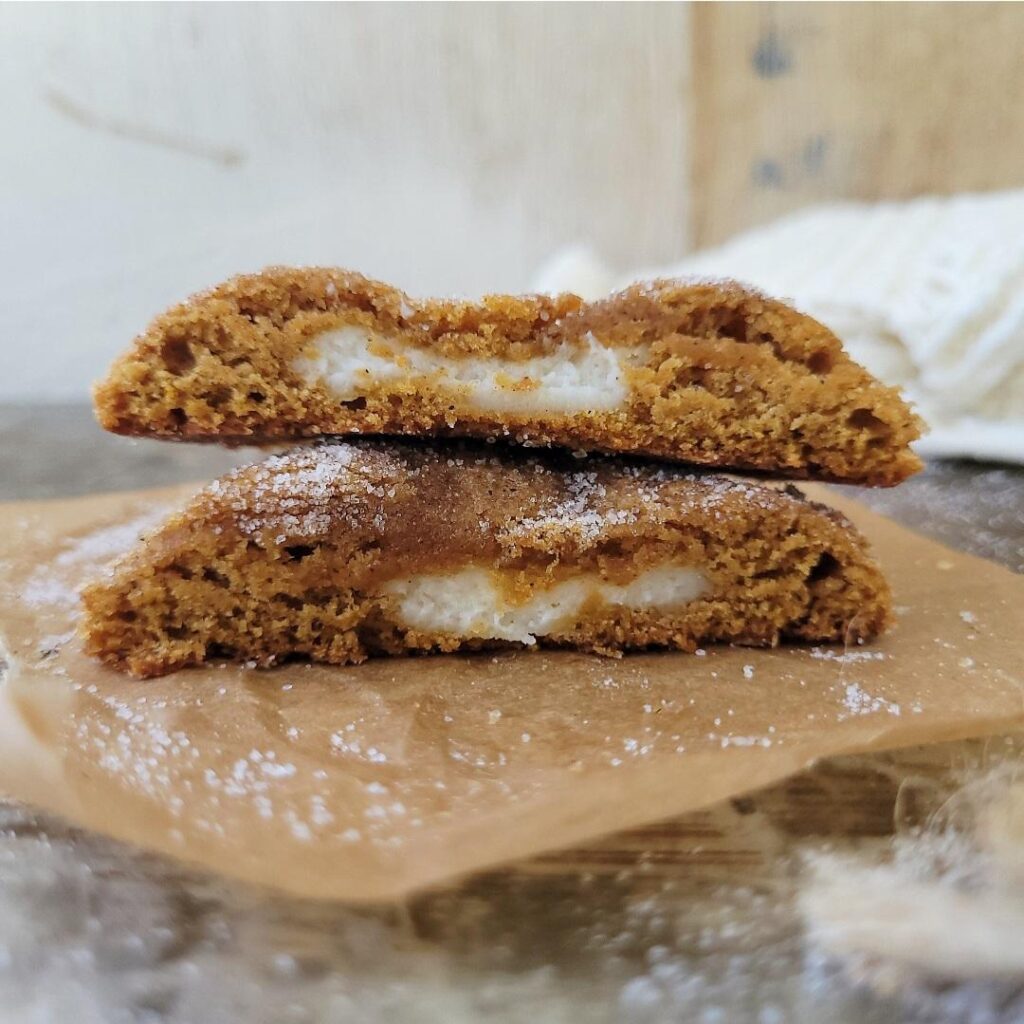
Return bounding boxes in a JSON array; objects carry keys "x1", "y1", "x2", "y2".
[{"x1": 0, "y1": 488, "x2": 1024, "y2": 901}]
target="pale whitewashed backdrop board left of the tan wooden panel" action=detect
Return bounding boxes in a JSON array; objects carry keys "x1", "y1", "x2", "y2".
[{"x1": 0, "y1": 3, "x2": 689, "y2": 399}]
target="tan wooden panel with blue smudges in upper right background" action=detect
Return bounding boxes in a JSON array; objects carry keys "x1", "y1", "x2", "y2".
[{"x1": 693, "y1": 3, "x2": 1024, "y2": 245}]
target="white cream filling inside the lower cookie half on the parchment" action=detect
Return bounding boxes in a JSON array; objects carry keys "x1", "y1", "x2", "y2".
[{"x1": 383, "y1": 565, "x2": 708, "y2": 644}]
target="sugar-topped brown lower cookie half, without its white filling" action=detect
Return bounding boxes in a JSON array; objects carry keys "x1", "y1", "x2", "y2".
[{"x1": 83, "y1": 441, "x2": 889, "y2": 676}]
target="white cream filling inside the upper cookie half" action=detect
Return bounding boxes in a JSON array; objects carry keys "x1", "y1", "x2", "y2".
[{"x1": 293, "y1": 326, "x2": 639, "y2": 416}]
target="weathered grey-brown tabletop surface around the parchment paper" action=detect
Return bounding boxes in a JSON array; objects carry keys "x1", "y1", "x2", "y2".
[{"x1": 0, "y1": 406, "x2": 1024, "y2": 1024}]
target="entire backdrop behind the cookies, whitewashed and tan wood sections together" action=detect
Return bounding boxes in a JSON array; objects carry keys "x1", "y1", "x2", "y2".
[{"x1": 8, "y1": 3, "x2": 1024, "y2": 400}]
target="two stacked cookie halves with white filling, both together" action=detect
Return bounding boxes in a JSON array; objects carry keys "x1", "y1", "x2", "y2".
[{"x1": 83, "y1": 269, "x2": 920, "y2": 676}]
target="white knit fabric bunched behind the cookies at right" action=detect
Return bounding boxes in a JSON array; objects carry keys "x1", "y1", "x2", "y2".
[{"x1": 538, "y1": 190, "x2": 1024, "y2": 463}]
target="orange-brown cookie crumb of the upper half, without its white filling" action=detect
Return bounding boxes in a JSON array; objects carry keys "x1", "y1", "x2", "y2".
[{"x1": 95, "y1": 267, "x2": 921, "y2": 485}]
